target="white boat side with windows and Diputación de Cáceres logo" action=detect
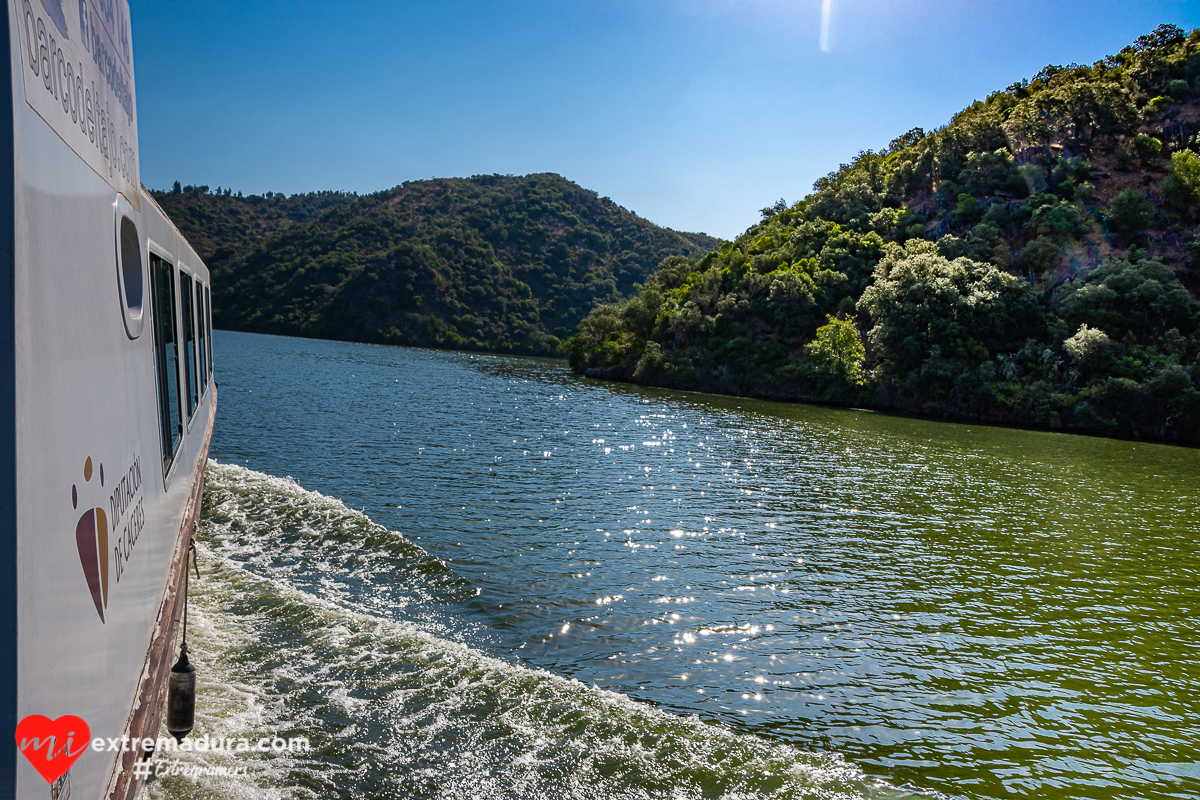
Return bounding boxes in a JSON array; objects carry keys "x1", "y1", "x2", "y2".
[{"x1": 0, "y1": 0, "x2": 216, "y2": 800}]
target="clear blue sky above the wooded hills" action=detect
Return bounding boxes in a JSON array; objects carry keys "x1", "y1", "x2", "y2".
[{"x1": 132, "y1": 0, "x2": 1200, "y2": 237}]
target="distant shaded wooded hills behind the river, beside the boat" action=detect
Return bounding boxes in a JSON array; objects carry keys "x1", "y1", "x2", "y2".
[{"x1": 155, "y1": 174, "x2": 719, "y2": 355}]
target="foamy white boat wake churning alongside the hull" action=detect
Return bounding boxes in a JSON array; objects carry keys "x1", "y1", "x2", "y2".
[{"x1": 149, "y1": 462, "x2": 912, "y2": 800}]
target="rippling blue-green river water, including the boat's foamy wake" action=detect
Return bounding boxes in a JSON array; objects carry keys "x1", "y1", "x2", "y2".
[{"x1": 154, "y1": 333, "x2": 1200, "y2": 799}]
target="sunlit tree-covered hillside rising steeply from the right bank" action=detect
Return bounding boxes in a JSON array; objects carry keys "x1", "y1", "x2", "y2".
[{"x1": 569, "y1": 25, "x2": 1200, "y2": 443}]
